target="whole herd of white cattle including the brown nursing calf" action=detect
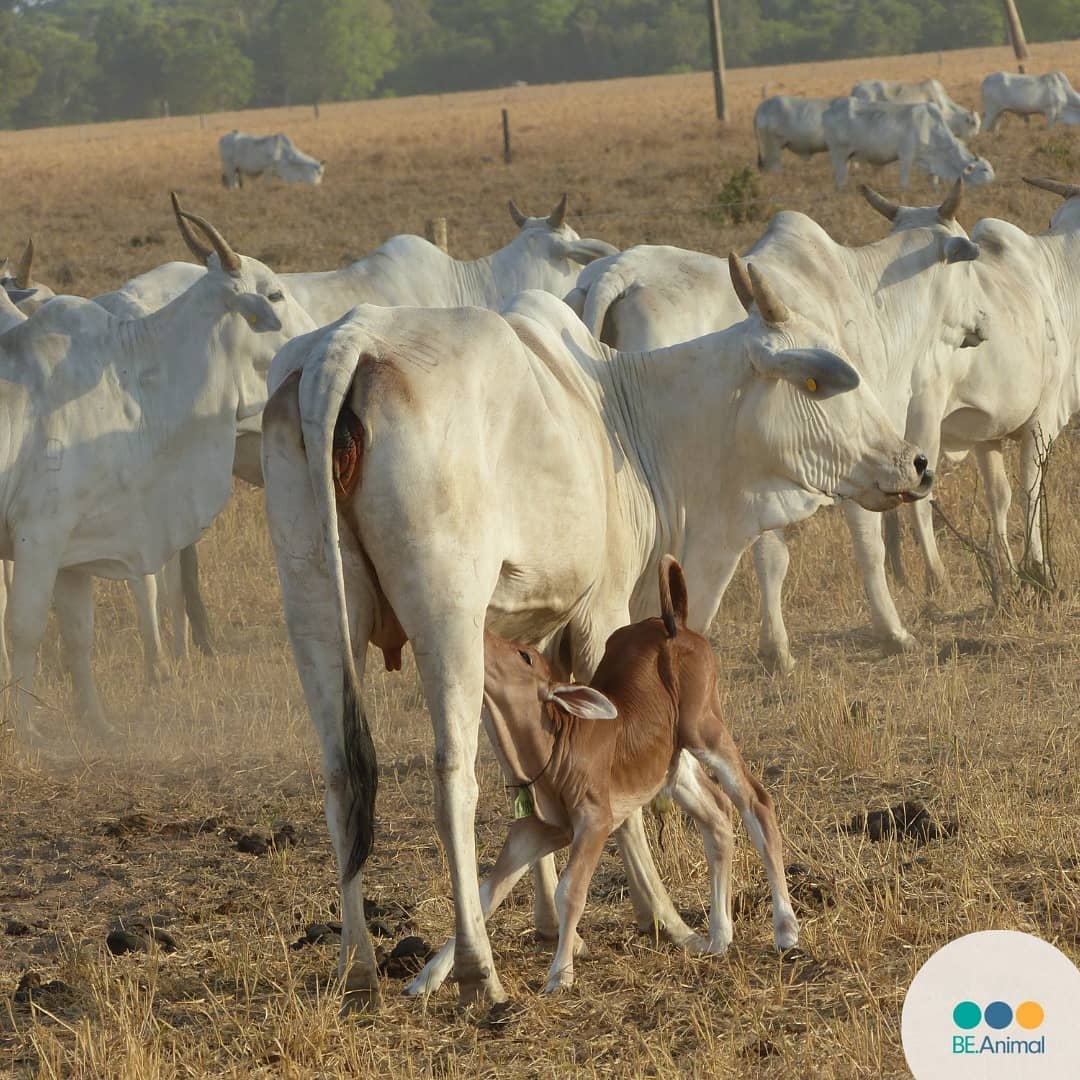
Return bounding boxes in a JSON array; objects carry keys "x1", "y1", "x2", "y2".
[{"x1": 0, "y1": 76, "x2": 1080, "y2": 1007}]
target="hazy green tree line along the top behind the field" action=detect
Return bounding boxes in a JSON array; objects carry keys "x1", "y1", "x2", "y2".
[{"x1": 0, "y1": 0, "x2": 1080, "y2": 127}]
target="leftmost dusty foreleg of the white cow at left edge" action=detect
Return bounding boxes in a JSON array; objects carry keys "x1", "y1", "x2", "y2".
[{"x1": 5, "y1": 548, "x2": 57, "y2": 741}]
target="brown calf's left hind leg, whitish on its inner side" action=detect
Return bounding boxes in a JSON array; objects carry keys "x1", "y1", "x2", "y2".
[{"x1": 672, "y1": 754, "x2": 734, "y2": 956}]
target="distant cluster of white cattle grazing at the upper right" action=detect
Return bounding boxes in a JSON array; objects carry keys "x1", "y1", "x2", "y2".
[{"x1": 754, "y1": 71, "x2": 1080, "y2": 191}]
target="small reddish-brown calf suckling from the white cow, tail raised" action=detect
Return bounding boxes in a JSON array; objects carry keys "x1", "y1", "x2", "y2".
[{"x1": 409, "y1": 555, "x2": 799, "y2": 994}]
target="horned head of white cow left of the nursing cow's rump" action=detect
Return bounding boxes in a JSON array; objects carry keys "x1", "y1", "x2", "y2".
[{"x1": 172, "y1": 192, "x2": 315, "y2": 431}]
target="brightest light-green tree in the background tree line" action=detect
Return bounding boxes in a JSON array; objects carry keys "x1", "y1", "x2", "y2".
[{"x1": 278, "y1": 0, "x2": 394, "y2": 102}]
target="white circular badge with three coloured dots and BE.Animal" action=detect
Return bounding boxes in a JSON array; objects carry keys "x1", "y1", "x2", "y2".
[{"x1": 901, "y1": 930, "x2": 1080, "y2": 1080}]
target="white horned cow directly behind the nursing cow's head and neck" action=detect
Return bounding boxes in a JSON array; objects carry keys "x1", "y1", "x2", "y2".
[{"x1": 570, "y1": 184, "x2": 985, "y2": 672}]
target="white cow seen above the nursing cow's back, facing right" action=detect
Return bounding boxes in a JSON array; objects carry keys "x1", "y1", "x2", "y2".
[{"x1": 283, "y1": 194, "x2": 618, "y2": 325}]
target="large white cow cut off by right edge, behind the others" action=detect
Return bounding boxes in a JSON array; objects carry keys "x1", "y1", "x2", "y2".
[{"x1": 876, "y1": 177, "x2": 1080, "y2": 600}]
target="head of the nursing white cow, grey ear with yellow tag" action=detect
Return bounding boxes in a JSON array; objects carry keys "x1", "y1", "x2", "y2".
[{"x1": 728, "y1": 254, "x2": 933, "y2": 511}]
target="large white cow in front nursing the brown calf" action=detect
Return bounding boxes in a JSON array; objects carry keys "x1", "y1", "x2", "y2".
[{"x1": 262, "y1": 256, "x2": 930, "y2": 1003}]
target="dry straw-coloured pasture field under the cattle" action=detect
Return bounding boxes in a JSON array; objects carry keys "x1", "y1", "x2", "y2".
[{"x1": 0, "y1": 43, "x2": 1080, "y2": 1080}]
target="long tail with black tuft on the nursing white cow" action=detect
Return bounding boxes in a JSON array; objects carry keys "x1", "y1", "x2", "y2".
[{"x1": 299, "y1": 346, "x2": 379, "y2": 881}]
